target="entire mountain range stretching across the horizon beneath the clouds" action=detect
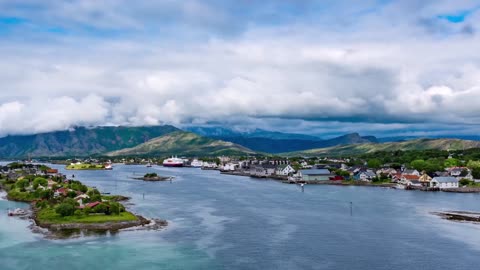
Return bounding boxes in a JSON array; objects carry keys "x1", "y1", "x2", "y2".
[{"x1": 0, "y1": 125, "x2": 480, "y2": 159}]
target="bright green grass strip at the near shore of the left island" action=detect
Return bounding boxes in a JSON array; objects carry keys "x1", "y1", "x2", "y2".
[{"x1": 37, "y1": 208, "x2": 138, "y2": 224}]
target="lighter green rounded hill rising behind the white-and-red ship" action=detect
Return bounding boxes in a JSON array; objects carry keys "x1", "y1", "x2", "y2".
[{"x1": 107, "y1": 131, "x2": 254, "y2": 156}]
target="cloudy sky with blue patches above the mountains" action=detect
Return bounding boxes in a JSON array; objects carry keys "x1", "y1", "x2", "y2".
[{"x1": 0, "y1": 0, "x2": 480, "y2": 137}]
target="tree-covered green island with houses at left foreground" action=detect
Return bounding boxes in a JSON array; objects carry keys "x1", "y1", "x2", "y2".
[{"x1": 0, "y1": 162, "x2": 167, "y2": 236}]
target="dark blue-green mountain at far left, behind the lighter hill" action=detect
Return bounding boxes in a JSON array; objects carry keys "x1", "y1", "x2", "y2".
[{"x1": 0, "y1": 126, "x2": 179, "y2": 159}]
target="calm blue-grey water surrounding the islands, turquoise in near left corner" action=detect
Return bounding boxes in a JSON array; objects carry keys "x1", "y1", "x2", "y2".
[{"x1": 0, "y1": 162, "x2": 480, "y2": 270}]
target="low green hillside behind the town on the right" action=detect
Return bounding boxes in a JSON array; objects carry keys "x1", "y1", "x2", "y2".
[{"x1": 284, "y1": 139, "x2": 480, "y2": 156}]
